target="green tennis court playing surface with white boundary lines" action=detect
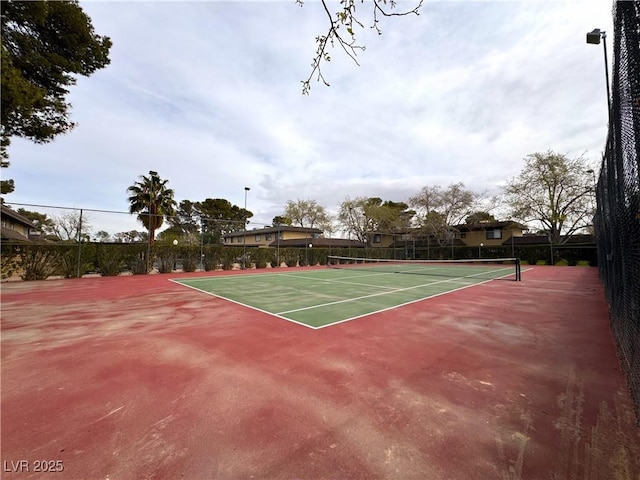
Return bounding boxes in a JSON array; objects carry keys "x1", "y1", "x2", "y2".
[{"x1": 173, "y1": 262, "x2": 516, "y2": 328}]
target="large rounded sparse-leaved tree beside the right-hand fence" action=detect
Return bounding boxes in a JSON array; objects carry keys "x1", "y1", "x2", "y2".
[{"x1": 504, "y1": 150, "x2": 595, "y2": 244}]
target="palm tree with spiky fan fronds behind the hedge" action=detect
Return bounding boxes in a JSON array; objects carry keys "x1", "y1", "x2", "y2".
[{"x1": 127, "y1": 171, "x2": 176, "y2": 243}]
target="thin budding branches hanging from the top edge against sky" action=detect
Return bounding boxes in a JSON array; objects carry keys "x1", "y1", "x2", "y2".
[{"x1": 296, "y1": 0, "x2": 423, "y2": 95}]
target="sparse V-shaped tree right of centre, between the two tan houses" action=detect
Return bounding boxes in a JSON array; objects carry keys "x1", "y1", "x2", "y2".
[{"x1": 409, "y1": 182, "x2": 479, "y2": 245}]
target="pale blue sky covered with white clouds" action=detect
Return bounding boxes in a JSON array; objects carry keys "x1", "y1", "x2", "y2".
[{"x1": 2, "y1": 0, "x2": 613, "y2": 234}]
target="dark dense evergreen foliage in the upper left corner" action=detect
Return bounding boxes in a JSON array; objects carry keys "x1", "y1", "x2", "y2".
[{"x1": 0, "y1": 0, "x2": 111, "y2": 159}]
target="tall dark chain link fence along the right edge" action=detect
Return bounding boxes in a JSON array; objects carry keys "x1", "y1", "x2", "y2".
[{"x1": 594, "y1": 1, "x2": 640, "y2": 422}]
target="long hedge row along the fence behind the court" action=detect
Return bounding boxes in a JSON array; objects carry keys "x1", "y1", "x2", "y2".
[{"x1": 1, "y1": 243, "x2": 597, "y2": 280}]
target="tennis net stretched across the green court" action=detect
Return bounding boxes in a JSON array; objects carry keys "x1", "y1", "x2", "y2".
[{"x1": 327, "y1": 255, "x2": 522, "y2": 281}]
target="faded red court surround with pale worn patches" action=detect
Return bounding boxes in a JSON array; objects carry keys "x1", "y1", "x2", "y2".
[{"x1": 0, "y1": 267, "x2": 640, "y2": 480}]
